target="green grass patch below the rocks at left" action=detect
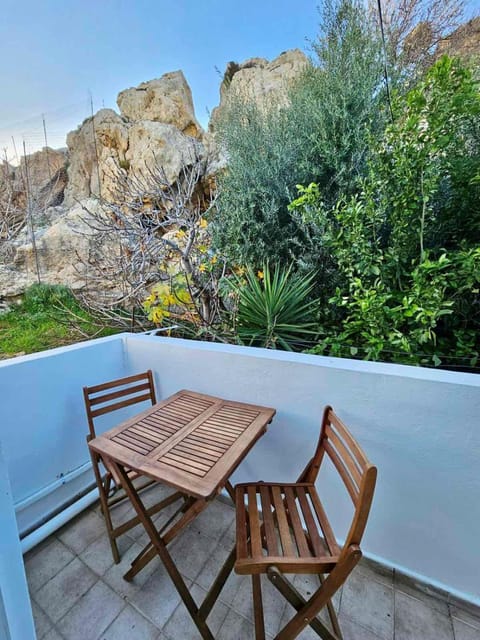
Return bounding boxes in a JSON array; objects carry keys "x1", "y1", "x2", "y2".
[{"x1": 0, "y1": 284, "x2": 118, "y2": 358}]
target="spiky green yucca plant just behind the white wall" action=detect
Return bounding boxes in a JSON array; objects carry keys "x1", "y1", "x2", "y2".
[{"x1": 230, "y1": 264, "x2": 318, "y2": 351}]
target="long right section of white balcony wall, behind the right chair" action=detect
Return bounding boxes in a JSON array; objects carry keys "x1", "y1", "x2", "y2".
[{"x1": 126, "y1": 336, "x2": 480, "y2": 603}]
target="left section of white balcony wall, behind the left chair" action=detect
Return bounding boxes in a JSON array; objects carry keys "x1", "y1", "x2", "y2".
[{"x1": 0, "y1": 336, "x2": 131, "y2": 534}]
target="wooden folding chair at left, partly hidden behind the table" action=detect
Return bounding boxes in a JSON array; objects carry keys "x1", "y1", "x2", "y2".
[{"x1": 83, "y1": 370, "x2": 184, "y2": 564}]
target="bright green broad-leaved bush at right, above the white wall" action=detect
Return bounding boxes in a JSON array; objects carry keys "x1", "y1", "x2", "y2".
[{"x1": 290, "y1": 57, "x2": 480, "y2": 366}]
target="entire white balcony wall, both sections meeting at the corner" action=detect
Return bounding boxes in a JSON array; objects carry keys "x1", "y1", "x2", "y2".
[{"x1": 0, "y1": 334, "x2": 480, "y2": 604}]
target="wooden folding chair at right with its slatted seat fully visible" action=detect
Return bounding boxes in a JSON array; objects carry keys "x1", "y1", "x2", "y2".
[{"x1": 235, "y1": 407, "x2": 377, "y2": 640}]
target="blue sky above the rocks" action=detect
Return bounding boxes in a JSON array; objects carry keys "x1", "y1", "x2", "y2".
[{"x1": 0, "y1": 0, "x2": 480, "y2": 160}]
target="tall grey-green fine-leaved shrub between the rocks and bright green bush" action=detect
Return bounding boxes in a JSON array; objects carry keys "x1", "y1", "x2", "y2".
[{"x1": 213, "y1": 0, "x2": 383, "y2": 273}]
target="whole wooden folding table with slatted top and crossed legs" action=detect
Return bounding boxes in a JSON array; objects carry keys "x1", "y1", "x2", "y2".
[{"x1": 88, "y1": 390, "x2": 275, "y2": 640}]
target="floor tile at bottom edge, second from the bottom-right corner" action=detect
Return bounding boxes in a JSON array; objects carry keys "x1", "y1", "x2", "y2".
[{"x1": 395, "y1": 591, "x2": 454, "y2": 640}]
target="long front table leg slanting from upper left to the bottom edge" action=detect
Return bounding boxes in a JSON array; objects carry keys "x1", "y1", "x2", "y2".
[{"x1": 112, "y1": 461, "x2": 215, "y2": 640}]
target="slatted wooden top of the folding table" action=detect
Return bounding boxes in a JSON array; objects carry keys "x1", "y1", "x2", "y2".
[{"x1": 89, "y1": 390, "x2": 275, "y2": 498}]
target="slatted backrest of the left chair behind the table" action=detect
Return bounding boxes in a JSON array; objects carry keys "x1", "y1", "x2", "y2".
[{"x1": 83, "y1": 370, "x2": 156, "y2": 438}]
